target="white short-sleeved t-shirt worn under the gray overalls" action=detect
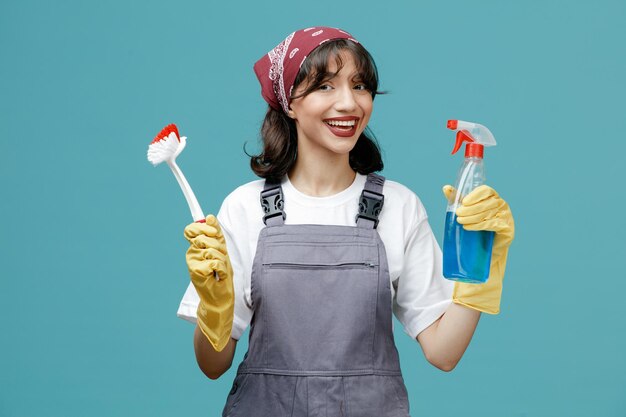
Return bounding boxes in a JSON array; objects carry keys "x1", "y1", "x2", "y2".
[{"x1": 177, "y1": 174, "x2": 453, "y2": 340}]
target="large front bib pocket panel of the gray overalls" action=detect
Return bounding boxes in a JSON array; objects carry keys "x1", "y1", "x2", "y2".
[{"x1": 262, "y1": 239, "x2": 379, "y2": 374}]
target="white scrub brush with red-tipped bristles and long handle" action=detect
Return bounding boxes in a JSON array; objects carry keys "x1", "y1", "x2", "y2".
[{"x1": 148, "y1": 123, "x2": 204, "y2": 222}]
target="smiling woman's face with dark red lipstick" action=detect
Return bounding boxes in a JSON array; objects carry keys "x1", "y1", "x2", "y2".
[{"x1": 289, "y1": 53, "x2": 373, "y2": 161}]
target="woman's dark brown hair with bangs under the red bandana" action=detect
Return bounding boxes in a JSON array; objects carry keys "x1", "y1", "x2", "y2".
[{"x1": 246, "y1": 39, "x2": 384, "y2": 181}]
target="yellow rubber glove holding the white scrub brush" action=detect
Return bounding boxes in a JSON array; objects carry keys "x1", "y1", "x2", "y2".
[{"x1": 185, "y1": 214, "x2": 235, "y2": 352}]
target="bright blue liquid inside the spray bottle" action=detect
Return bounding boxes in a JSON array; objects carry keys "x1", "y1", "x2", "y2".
[{"x1": 443, "y1": 211, "x2": 495, "y2": 284}]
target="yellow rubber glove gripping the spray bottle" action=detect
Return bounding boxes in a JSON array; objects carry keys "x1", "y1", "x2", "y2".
[{"x1": 443, "y1": 185, "x2": 515, "y2": 314}]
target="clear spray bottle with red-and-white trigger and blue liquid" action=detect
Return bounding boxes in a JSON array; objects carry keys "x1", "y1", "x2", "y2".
[{"x1": 443, "y1": 120, "x2": 496, "y2": 283}]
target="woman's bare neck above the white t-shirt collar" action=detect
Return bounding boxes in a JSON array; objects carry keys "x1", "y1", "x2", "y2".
[{"x1": 289, "y1": 155, "x2": 356, "y2": 197}]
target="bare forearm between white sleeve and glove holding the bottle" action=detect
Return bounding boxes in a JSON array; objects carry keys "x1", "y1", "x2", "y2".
[{"x1": 417, "y1": 303, "x2": 480, "y2": 372}]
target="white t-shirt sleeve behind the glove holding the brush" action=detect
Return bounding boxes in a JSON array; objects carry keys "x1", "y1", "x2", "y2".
[{"x1": 177, "y1": 192, "x2": 252, "y2": 340}]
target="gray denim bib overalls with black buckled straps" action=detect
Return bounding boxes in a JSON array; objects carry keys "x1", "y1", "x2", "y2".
[{"x1": 222, "y1": 174, "x2": 409, "y2": 417}]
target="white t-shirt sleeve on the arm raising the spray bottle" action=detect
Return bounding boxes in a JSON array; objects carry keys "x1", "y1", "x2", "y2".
[{"x1": 393, "y1": 197, "x2": 453, "y2": 339}]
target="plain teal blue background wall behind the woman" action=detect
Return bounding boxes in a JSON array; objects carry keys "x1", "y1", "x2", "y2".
[{"x1": 0, "y1": 0, "x2": 626, "y2": 417}]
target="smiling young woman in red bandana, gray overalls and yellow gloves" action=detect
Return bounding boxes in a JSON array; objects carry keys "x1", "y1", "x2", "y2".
[{"x1": 174, "y1": 27, "x2": 513, "y2": 417}]
